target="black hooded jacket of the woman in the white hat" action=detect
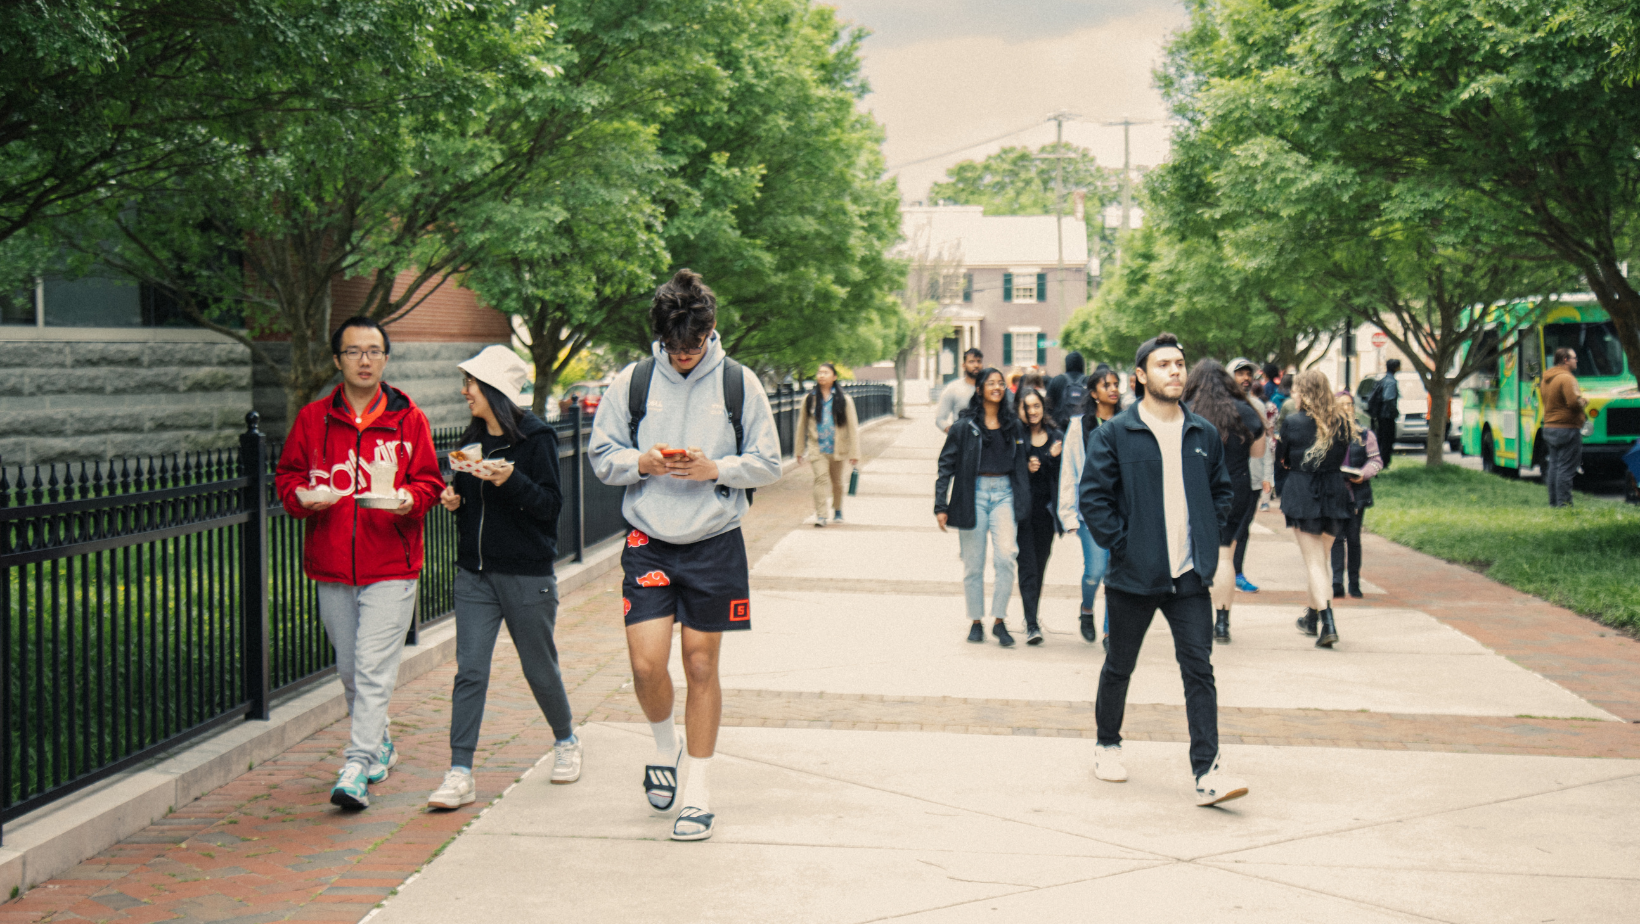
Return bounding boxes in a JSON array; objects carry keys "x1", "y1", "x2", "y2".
[{"x1": 451, "y1": 414, "x2": 564, "y2": 574}]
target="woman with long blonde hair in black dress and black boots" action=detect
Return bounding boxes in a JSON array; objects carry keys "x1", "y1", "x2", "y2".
[{"x1": 1276, "y1": 369, "x2": 1360, "y2": 648}]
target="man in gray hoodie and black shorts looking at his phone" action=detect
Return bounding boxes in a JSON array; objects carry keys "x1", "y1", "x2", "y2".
[{"x1": 587, "y1": 269, "x2": 781, "y2": 840}]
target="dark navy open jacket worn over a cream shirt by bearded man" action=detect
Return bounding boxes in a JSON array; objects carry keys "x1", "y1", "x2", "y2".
[{"x1": 1077, "y1": 404, "x2": 1235, "y2": 594}]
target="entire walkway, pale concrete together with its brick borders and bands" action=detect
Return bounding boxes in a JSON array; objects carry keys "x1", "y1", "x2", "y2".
[{"x1": 12, "y1": 409, "x2": 1640, "y2": 924}]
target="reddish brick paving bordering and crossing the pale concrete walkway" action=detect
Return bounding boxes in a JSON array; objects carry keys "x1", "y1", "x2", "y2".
[{"x1": 0, "y1": 415, "x2": 1640, "y2": 924}]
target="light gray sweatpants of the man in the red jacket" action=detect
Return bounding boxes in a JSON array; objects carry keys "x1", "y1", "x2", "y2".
[{"x1": 318, "y1": 579, "x2": 415, "y2": 763}]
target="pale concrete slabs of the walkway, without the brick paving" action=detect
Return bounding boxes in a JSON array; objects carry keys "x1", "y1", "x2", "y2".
[{"x1": 374, "y1": 415, "x2": 1640, "y2": 924}]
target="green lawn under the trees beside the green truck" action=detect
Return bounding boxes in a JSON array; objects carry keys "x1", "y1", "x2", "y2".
[{"x1": 1366, "y1": 461, "x2": 1640, "y2": 632}]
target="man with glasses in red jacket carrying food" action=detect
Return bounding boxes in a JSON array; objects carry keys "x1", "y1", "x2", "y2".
[{"x1": 274, "y1": 317, "x2": 444, "y2": 809}]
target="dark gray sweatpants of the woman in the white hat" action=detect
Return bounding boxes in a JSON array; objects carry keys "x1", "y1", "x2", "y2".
[{"x1": 449, "y1": 568, "x2": 576, "y2": 766}]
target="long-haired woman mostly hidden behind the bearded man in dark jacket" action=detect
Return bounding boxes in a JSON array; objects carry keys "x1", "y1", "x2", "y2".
[{"x1": 1181, "y1": 359, "x2": 1264, "y2": 645}]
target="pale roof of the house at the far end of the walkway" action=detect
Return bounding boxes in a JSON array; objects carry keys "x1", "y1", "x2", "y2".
[{"x1": 895, "y1": 205, "x2": 1087, "y2": 269}]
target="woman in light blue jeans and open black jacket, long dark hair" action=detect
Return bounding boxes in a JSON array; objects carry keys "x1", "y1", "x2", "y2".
[{"x1": 933, "y1": 368, "x2": 1030, "y2": 648}]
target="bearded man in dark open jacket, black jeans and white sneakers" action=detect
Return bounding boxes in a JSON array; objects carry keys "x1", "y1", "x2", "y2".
[{"x1": 1079, "y1": 333, "x2": 1246, "y2": 806}]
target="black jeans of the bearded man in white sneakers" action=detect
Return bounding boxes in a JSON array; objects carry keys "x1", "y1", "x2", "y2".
[{"x1": 1094, "y1": 571, "x2": 1235, "y2": 776}]
